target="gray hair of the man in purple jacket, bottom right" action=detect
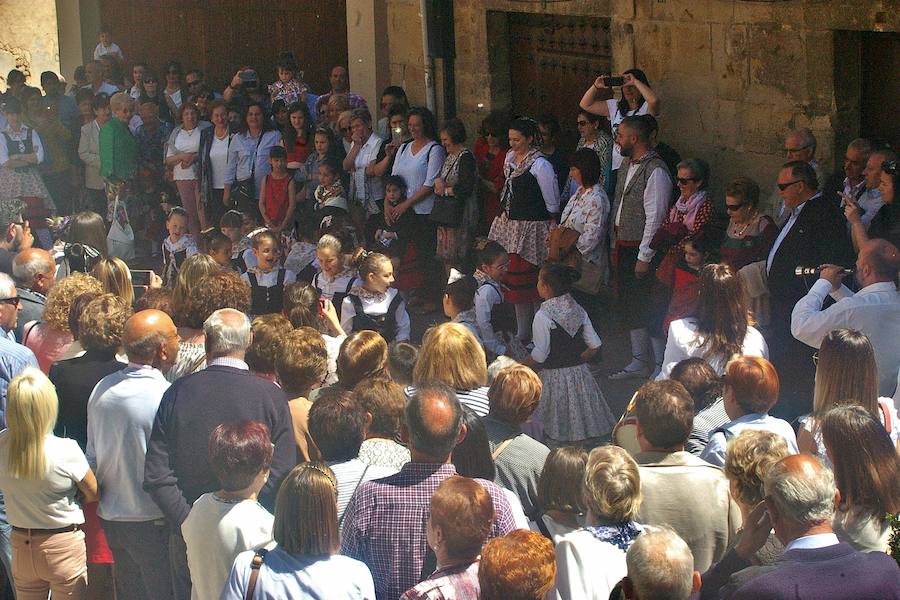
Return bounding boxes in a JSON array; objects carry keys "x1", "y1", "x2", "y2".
[{"x1": 763, "y1": 457, "x2": 836, "y2": 527}]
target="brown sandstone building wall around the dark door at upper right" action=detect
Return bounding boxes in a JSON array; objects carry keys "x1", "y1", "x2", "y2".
[{"x1": 378, "y1": 0, "x2": 900, "y2": 198}]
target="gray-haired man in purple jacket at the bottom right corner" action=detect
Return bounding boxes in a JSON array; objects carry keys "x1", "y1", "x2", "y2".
[{"x1": 700, "y1": 454, "x2": 900, "y2": 600}]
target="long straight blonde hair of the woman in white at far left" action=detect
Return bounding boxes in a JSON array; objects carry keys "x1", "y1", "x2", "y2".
[{"x1": 6, "y1": 368, "x2": 59, "y2": 479}]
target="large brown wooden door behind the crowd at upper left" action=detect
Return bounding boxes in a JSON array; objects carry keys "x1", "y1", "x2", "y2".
[{"x1": 100, "y1": 0, "x2": 347, "y2": 93}]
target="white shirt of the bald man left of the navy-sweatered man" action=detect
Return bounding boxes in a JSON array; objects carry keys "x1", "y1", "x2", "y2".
[{"x1": 87, "y1": 363, "x2": 169, "y2": 521}]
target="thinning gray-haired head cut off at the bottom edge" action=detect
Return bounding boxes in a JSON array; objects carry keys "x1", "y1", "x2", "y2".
[{"x1": 625, "y1": 527, "x2": 694, "y2": 600}]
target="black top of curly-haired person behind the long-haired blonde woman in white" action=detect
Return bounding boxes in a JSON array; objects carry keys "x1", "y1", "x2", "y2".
[{"x1": 49, "y1": 351, "x2": 127, "y2": 450}]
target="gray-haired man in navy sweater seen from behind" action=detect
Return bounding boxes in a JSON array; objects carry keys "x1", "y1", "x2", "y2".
[{"x1": 144, "y1": 308, "x2": 297, "y2": 600}]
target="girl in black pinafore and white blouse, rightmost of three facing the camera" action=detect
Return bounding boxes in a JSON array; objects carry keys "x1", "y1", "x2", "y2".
[{"x1": 341, "y1": 248, "x2": 409, "y2": 343}]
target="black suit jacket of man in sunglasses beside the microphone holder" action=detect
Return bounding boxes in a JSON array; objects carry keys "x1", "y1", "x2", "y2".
[{"x1": 768, "y1": 195, "x2": 854, "y2": 324}]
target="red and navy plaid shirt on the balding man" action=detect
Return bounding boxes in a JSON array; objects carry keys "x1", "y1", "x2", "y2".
[{"x1": 341, "y1": 462, "x2": 516, "y2": 600}]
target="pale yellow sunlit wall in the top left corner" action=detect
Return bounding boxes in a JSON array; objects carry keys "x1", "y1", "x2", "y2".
[{"x1": 0, "y1": 0, "x2": 59, "y2": 90}]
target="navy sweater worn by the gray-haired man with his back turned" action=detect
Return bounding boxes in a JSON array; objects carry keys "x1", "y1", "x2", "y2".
[{"x1": 144, "y1": 365, "x2": 297, "y2": 526}]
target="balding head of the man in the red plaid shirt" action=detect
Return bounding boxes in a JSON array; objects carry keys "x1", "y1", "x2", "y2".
[{"x1": 406, "y1": 383, "x2": 462, "y2": 461}]
